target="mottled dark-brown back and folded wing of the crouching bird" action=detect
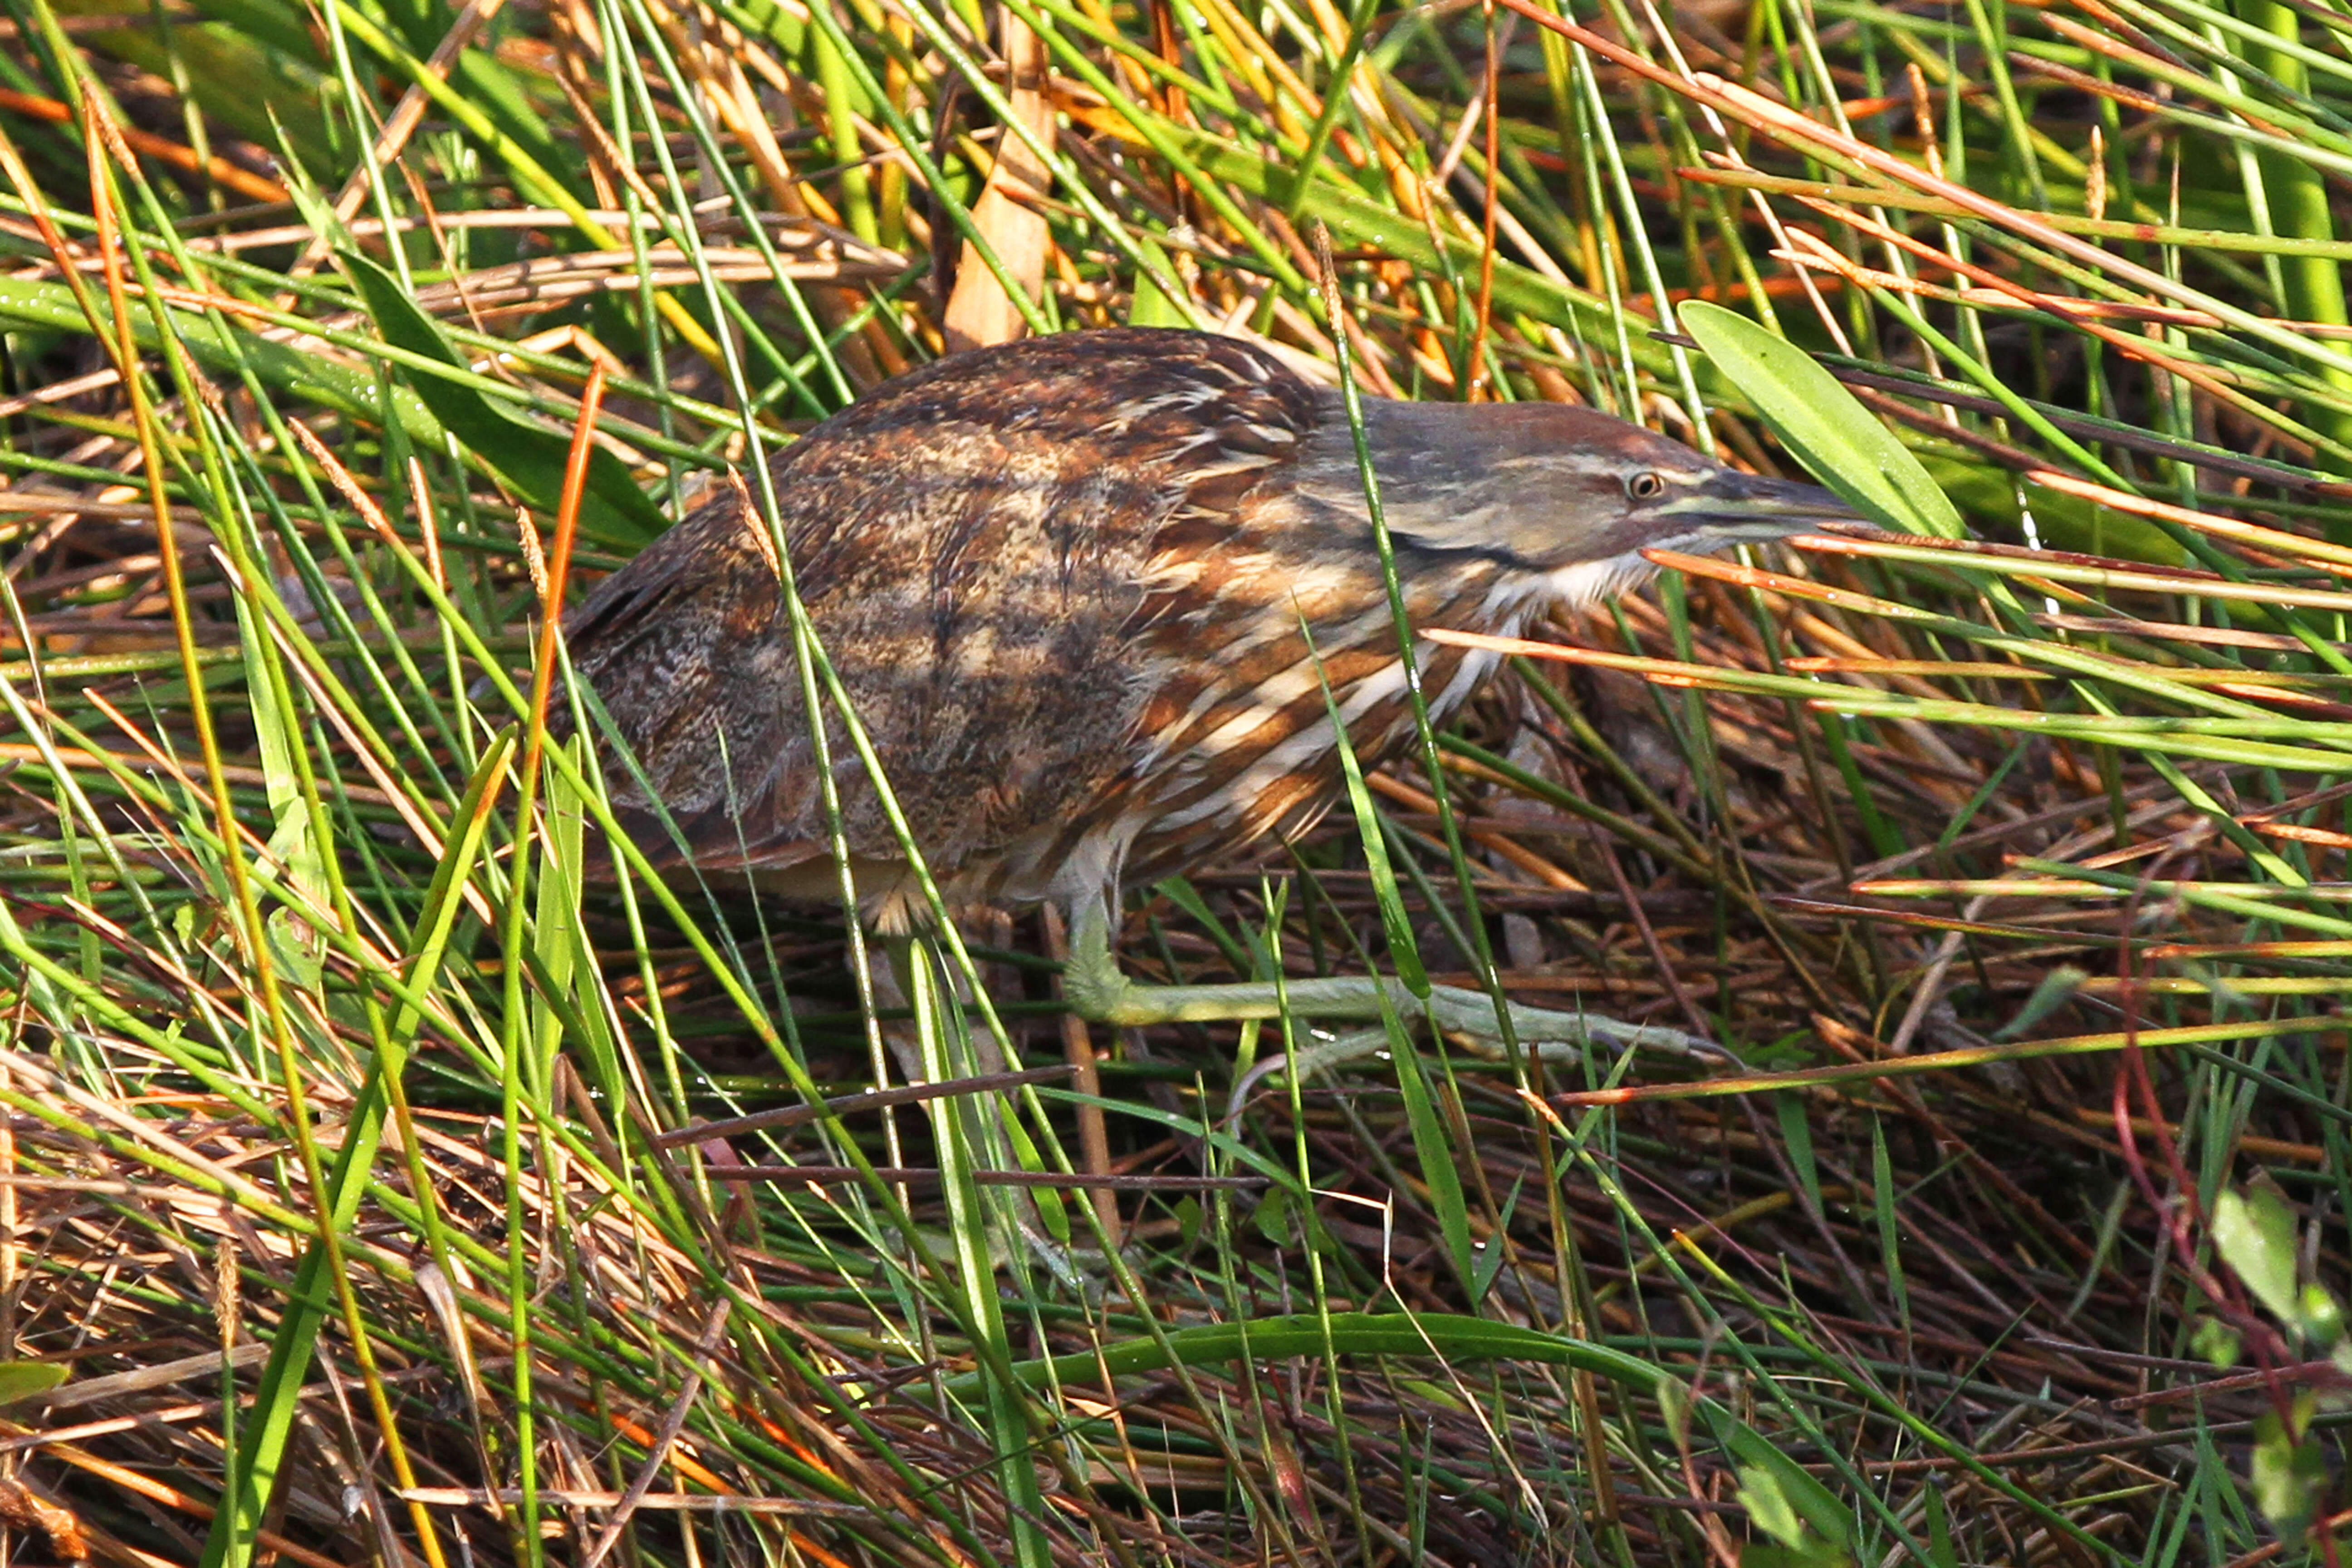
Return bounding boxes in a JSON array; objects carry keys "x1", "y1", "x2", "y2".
[{"x1": 550, "y1": 332, "x2": 1317, "y2": 917}]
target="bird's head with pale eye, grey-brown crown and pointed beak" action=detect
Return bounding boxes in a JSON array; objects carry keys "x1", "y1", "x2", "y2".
[{"x1": 1301, "y1": 400, "x2": 1861, "y2": 602}]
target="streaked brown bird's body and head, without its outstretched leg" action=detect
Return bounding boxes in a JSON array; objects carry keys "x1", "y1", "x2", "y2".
[{"x1": 562, "y1": 327, "x2": 1856, "y2": 1044}]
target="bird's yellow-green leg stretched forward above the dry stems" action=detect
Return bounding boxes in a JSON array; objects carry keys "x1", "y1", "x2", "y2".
[{"x1": 1061, "y1": 900, "x2": 1724, "y2": 1058}]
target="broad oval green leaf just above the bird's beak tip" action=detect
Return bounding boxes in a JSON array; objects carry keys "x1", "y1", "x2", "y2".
[{"x1": 1679, "y1": 299, "x2": 1969, "y2": 539}]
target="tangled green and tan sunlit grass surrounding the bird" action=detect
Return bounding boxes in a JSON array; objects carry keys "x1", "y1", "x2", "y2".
[{"x1": 0, "y1": 0, "x2": 2352, "y2": 1568}]
